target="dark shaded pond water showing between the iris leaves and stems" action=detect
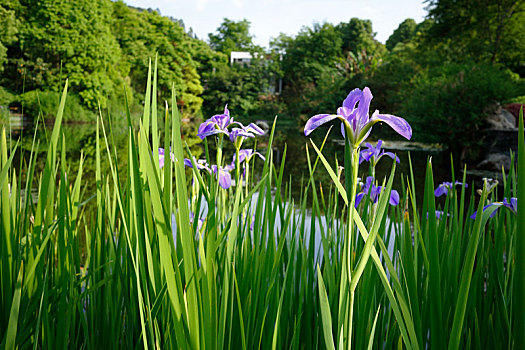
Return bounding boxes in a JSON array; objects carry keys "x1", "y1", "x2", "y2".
[{"x1": 0, "y1": 113, "x2": 490, "y2": 211}]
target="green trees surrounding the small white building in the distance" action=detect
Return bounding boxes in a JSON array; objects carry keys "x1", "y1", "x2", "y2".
[{"x1": 198, "y1": 19, "x2": 283, "y2": 122}]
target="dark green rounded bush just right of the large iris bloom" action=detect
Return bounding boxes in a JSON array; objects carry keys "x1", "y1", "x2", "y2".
[{"x1": 399, "y1": 64, "x2": 523, "y2": 150}]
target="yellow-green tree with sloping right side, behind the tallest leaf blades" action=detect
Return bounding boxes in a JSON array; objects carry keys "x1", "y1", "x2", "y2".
[{"x1": 113, "y1": 1, "x2": 202, "y2": 116}]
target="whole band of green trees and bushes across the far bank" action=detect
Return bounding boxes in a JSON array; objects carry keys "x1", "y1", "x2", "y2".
[{"x1": 0, "y1": 0, "x2": 525, "y2": 149}]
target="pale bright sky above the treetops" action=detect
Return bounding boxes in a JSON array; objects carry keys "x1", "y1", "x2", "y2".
[{"x1": 124, "y1": 0, "x2": 427, "y2": 47}]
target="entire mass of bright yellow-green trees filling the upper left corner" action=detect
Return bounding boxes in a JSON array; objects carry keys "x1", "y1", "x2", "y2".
[{"x1": 0, "y1": 0, "x2": 202, "y2": 116}]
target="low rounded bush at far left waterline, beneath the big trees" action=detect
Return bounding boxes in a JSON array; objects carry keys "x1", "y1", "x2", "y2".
[{"x1": 13, "y1": 90, "x2": 96, "y2": 122}]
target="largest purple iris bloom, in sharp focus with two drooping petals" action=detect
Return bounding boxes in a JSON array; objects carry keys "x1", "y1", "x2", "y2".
[{"x1": 304, "y1": 87, "x2": 412, "y2": 147}]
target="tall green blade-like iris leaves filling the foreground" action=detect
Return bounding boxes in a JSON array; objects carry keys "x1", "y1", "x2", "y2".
[{"x1": 0, "y1": 64, "x2": 525, "y2": 349}]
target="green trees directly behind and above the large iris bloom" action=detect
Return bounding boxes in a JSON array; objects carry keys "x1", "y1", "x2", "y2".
[{"x1": 273, "y1": 18, "x2": 385, "y2": 118}]
